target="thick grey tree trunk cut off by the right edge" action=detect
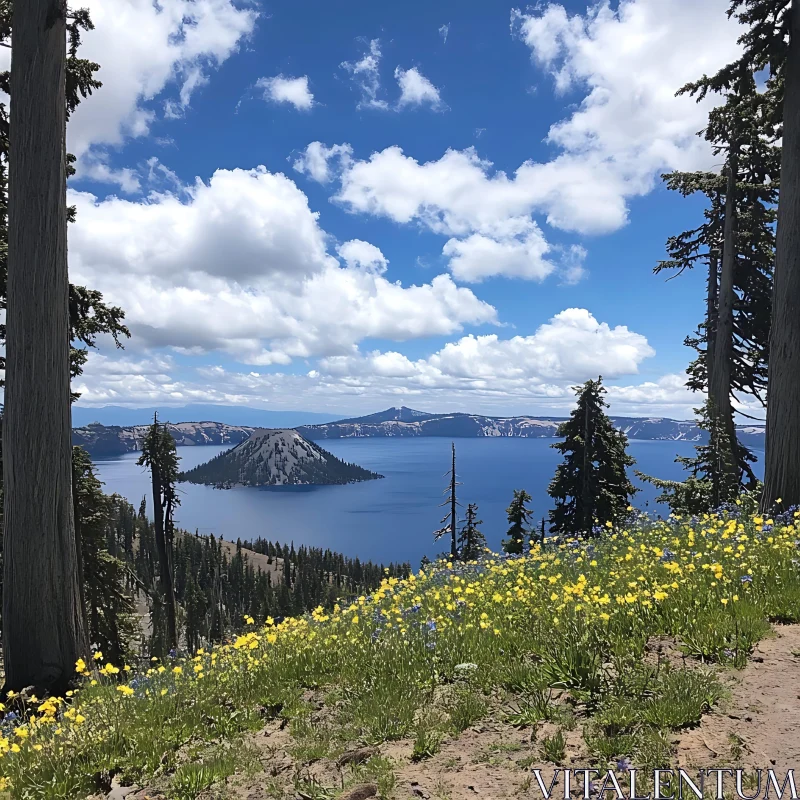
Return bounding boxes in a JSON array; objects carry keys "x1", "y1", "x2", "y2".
[{"x1": 763, "y1": 0, "x2": 800, "y2": 510}]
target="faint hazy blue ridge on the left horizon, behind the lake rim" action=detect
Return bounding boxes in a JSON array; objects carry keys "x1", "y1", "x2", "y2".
[{"x1": 72, "y1": 403, "x2": 331, "y2": 428}]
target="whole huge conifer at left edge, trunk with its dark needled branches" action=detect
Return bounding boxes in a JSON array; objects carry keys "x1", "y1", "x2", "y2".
[{"x1": 0, "y1": 0, "x2": 129, "y2": 689}]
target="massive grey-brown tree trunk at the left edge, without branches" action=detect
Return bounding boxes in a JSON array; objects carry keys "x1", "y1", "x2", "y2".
[{"x1": 3, "y1": 0, "x2": 87, "y2": 691}]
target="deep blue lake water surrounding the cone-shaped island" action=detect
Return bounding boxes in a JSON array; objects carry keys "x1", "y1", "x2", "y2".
[{"x1": 90, "y1": 438, "x2": 762, "y2": 567}]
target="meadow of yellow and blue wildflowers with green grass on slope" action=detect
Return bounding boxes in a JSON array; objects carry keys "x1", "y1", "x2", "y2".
[{"x1": 0, "y1": 500, "x2": 800, "y2": 798}]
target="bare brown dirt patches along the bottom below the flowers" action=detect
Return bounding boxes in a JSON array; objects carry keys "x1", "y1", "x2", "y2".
[{"x1": 120, "y1": 625, "x2": 800, "y2": 800}]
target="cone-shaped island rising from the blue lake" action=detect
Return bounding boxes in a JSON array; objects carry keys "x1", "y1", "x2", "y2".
[{"x1": 178, "y1": 429, "x2": 383, "y2": 488}]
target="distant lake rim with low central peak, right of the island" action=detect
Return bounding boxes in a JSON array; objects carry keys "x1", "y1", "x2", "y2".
[{"x1": 297, "y1": 407, "x2": 764, "y2": 447}]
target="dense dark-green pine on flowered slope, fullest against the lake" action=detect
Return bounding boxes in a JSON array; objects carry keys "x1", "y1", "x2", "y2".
[{"x1": 548, "y1": 378, "x2": 638, "y2": 535}]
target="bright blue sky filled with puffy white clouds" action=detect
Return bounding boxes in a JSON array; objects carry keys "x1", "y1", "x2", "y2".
[{"x1": 68, "y1": 0, "x2": 752, "y2": 417}]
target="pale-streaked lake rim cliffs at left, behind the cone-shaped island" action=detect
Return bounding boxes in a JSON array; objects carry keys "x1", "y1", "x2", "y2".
[{"x1": 72, "y1": 422, "x2": 256, "y2": 458}]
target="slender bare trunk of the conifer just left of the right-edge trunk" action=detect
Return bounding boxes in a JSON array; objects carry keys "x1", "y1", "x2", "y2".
[{"x1": 708, "y1": 150, "x2": 739, "y2": 500}]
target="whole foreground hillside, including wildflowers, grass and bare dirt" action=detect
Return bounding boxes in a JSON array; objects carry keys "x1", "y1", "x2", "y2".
[{"x1": 7, "y1": 506, "x2": 800, "y2": 800}]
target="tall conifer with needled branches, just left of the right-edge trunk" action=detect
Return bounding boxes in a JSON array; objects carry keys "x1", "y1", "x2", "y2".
[{"x1": 655, "y1": 65, "x2": 780, "y2": 495}]
